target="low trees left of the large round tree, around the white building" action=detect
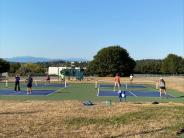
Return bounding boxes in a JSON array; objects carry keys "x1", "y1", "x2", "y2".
[{"x1": 0, "y1": 59, "x2": 88, "y2": 76}]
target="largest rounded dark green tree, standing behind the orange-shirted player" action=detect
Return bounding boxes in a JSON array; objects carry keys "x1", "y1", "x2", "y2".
[{"x1": 87, "y1": 46, "x2": 135, "y2": 76}]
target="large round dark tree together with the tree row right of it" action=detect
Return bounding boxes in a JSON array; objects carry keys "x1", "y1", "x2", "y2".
[{"x1": 87, "y1": 45, "x2": 184, "y2": 76}]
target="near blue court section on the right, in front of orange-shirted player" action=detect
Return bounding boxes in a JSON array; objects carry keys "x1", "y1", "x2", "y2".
[{"x1": 97, "y1": 90, "x2": 175, "y2": 98}]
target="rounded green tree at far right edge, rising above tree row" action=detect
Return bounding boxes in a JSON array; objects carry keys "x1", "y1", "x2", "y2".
[{"x1": 161, "y1": 54, "x2": 183, "y2": 74}]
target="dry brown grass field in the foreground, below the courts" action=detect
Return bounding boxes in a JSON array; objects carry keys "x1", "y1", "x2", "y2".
[{"x1": 0, "y1": 101, "x2": 184, "y2": 138}]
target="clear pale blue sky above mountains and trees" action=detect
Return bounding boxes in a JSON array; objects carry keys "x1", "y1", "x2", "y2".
[{"x1": 0, "y1": 0, "x2": 184, "y2": 60}]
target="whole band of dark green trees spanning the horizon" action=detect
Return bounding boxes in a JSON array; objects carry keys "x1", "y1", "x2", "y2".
[{"x1": 0, "y1": 45, "x2": 184, "y2": 76}]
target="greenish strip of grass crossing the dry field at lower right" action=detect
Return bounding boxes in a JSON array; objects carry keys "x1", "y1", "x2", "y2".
[{"x1": 65, "y1": 106, "x2": 184, "y2": 128}]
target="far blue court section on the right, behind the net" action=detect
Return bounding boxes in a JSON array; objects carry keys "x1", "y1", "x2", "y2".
[{"x1": 98, "y1": 84, "x2": 146, "y2": 88}]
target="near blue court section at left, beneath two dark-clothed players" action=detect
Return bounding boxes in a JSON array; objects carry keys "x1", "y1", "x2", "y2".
[{"x1": 0, "y1": 90, "x2": 56, "y2": 96}]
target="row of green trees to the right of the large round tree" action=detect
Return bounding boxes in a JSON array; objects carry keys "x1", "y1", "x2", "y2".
[{"x1": 134, "y1": 54, "x2": 184, "y2": 74}]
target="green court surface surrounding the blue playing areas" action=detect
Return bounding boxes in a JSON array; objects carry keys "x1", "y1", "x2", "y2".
[{"x1": 0, "y1": 83, "x2": 184, "y2": 103}]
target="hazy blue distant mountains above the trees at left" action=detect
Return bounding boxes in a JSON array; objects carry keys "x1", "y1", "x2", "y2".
[{"x1": 4, "y1": 56, "x2": 87, "y2": 63}]
